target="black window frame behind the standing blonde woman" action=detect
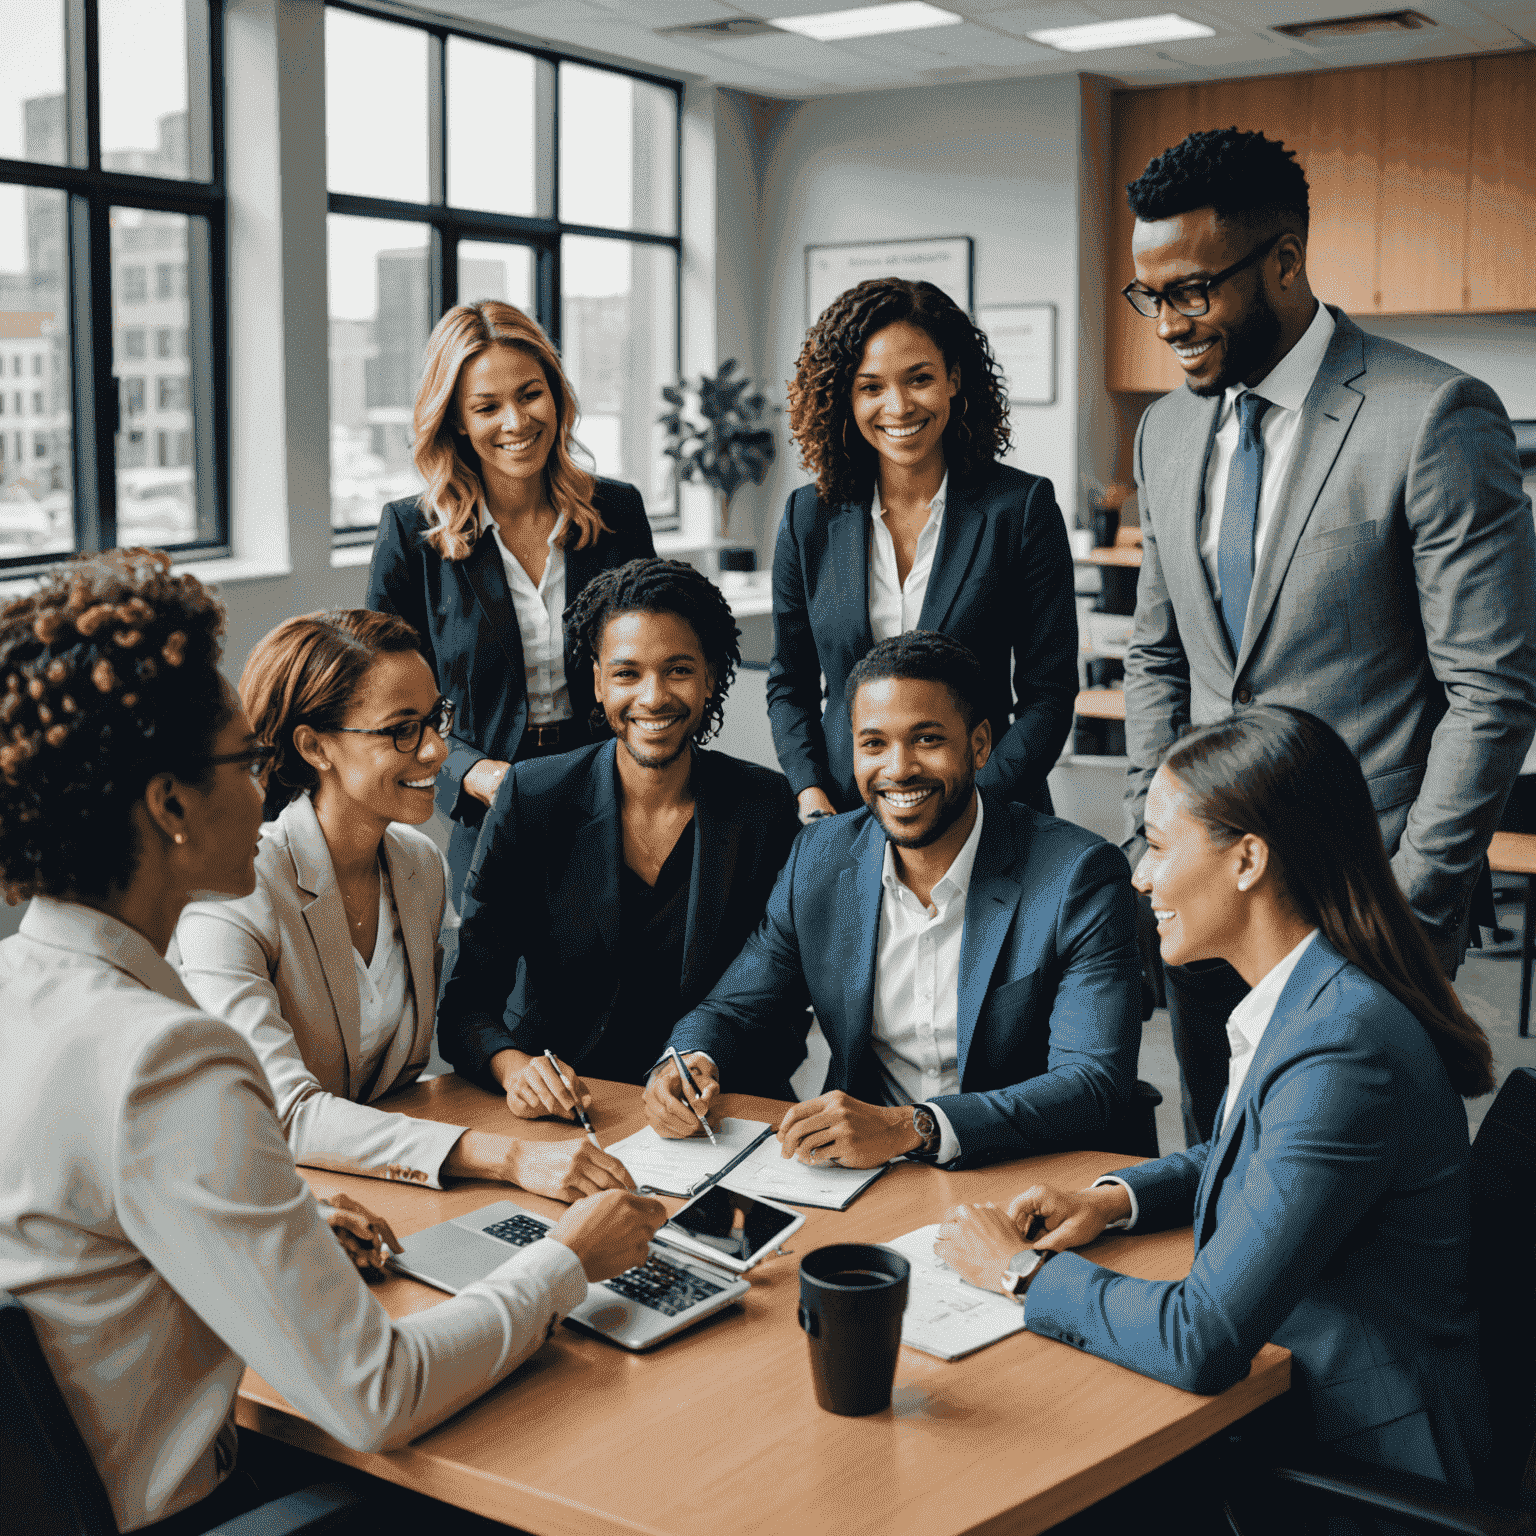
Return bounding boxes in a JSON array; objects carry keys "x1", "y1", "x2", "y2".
[{"x1": 326, "y1": 0, "x2": 684, "y2": 548}]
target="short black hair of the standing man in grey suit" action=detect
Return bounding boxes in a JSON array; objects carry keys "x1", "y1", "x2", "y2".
[{"x1": 1126, "y1": 127, "x2": 1310, "y2": 240}]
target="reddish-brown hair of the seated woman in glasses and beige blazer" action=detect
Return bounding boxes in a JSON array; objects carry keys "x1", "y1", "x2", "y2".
[{"x1": 240, "y1": 608, "x2": 421, "y2": 822}]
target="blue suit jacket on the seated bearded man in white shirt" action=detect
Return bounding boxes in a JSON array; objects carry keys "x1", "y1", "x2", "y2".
[{"x1": 671, "y1": 794, "x2": 1141, "y2": 1167}]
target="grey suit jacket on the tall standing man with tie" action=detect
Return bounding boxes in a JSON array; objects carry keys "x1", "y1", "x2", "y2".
[{"x1": 1126, "y1": 307, "x2": 1536, "y2": 958}]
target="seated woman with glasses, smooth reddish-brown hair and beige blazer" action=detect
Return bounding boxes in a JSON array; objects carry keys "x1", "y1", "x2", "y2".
[{"x1": 175, "y1": 610, "x2": 633, "y2": 1200}]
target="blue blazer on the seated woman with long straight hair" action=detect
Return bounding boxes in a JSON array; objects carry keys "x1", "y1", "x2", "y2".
[{"x1": 1026, "y1": 934, "x2": 1488, "y2": 1487}]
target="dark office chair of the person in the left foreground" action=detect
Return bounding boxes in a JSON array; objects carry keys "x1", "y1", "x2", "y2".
[{"x1": 0, "y1": 1290, "x2": 376, "y2": 1536}]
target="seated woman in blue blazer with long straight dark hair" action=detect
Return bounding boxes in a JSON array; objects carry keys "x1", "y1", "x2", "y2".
[{"x1": 935, "y1": 707, "x2": 1493, "y2": 1488}]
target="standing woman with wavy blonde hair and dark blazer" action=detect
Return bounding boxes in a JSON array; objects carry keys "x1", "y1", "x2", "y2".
[{"x1": 366, "y1": 300, "x2": 654, "y2": 899}]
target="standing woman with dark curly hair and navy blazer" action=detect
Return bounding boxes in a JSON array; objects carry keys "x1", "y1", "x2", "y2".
[{"x1": 768, "y1": 278, "x2": 1077, "y2": 820}]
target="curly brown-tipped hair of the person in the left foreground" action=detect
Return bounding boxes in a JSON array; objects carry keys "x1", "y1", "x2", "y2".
[{"x1": 0, "y1": 548, "x2": 232, "y2": 906}]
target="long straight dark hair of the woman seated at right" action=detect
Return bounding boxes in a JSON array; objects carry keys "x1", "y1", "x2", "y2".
[{"x1": 1163, "y1": 705, "x2": 1493, "y2": 1098}]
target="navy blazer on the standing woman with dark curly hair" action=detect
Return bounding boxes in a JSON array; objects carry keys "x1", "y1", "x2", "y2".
[{"x1": 768, "y1": 464, "x2": 1077, "y2": 811}]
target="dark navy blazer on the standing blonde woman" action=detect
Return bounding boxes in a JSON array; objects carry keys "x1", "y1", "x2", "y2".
[{"x1": 366, "y1": 479, "x2": 656, "y2": 899}]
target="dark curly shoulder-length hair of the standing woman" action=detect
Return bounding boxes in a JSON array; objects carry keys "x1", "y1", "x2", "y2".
[{"x1": 790, "y1": 278, "x2": 1012, "y2": 505}]
